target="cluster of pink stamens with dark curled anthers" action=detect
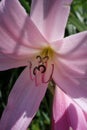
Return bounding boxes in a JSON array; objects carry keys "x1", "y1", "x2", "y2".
[{"x1": 28, "y1": 55, "x2": 54, "y2": 86}]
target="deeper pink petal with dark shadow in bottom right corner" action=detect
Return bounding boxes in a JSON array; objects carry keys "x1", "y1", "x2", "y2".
[{"x1": 52, "y1": 86, "x2": 87, "y2": 130}]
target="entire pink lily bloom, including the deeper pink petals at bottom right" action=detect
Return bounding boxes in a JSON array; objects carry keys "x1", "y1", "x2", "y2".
[{"x1": 0, "y1": 0, "x2": 87, "y2": 130}]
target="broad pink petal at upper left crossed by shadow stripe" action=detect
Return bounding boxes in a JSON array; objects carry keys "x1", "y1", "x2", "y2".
[{"x1": 0, "y1": 0, "x2": 46, "y2": 48}]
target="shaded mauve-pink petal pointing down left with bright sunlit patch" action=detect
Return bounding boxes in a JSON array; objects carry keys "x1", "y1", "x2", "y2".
[{"x1": 0, "y1": 68, "x2": 47, "y2": 130}]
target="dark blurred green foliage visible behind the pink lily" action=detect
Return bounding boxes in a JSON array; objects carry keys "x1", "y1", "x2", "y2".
[{"x1": 0, "y1": 0, "x2": 87, "y2": 130}]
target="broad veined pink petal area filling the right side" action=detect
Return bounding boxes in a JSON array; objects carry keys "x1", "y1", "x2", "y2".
[{"x1": 53, "y1": 32, "x2": 87, "y2": 112}]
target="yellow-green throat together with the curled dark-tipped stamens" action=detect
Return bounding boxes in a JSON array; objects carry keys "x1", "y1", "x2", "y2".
[{"x1": 29, "y1": 47, "x2": 54, "y2": 86}]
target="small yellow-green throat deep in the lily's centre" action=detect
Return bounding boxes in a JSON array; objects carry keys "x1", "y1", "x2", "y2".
[{"x1": 40, "y1": 46, "x2": 54, "y2": 59}]
